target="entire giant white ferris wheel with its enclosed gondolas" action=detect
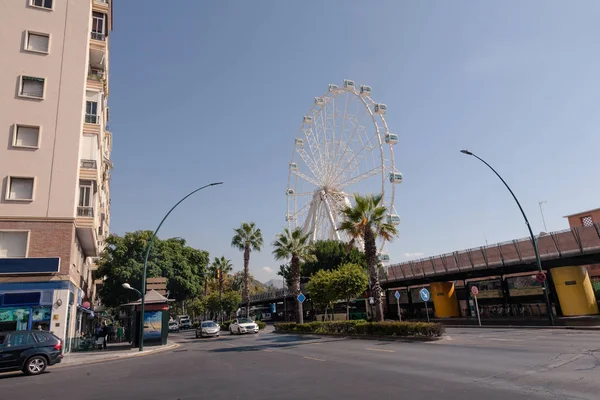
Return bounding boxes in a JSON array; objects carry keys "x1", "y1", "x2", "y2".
[{"x1": 286, "y1": 80, "x2": 402, "y2": 262}]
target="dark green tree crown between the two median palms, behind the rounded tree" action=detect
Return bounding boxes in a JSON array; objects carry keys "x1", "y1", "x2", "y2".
[{"x1": 302, "y1": 240, "x2": 367, "y2": 276}]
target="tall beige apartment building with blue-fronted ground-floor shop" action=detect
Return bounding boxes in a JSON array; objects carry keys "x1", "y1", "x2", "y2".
[{"x1": 0, "y1": 0, "x2": 112, "y2": 349}]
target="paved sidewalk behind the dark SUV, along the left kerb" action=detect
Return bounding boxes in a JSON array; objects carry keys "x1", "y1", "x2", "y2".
[{"x1": 56, "y1": 343, "x2": 179, "y2": 368}]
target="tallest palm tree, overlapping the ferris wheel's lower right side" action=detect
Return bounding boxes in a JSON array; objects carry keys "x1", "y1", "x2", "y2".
[{"x1": 338, "y1": 194, "x2": 398, "y2": 321}]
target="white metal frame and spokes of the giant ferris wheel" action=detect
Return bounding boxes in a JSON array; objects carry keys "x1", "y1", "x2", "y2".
[{"x1": 286, "y1": 81, "x2": 398, "y2": 254}]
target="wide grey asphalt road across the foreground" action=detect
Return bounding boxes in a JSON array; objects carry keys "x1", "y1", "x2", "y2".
[{"x1": 0, "y1": 328, "x2": 600, "y2": 400}]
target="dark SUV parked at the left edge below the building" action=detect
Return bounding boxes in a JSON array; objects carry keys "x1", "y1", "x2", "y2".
[{"x1": 0, "y1": 331, "x2": 63, "y2": 375}]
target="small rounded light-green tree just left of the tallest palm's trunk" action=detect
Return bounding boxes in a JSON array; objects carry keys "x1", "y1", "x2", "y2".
[{"x1": 330, "y1": 263, "x2": 369, "y2": 320}]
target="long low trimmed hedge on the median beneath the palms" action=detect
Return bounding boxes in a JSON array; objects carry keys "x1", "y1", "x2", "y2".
[{"x1": 275, "y1": 321, "x2": 444, "y2": 337}]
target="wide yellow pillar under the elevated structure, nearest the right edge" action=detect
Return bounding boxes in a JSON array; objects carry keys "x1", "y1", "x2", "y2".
[{"x1": 551, "y1": 266, "x2": 599, "y2": 317}]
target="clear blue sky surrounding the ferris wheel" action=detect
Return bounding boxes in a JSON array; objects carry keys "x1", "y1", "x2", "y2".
[{"x1": 109, "y1": 0, "x2": 600, "y2": 281}]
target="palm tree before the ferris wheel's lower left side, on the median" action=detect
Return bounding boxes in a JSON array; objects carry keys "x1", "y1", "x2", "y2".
[{"x1": 273, "y1": 228, "x2": 316, "y2": 324}]
